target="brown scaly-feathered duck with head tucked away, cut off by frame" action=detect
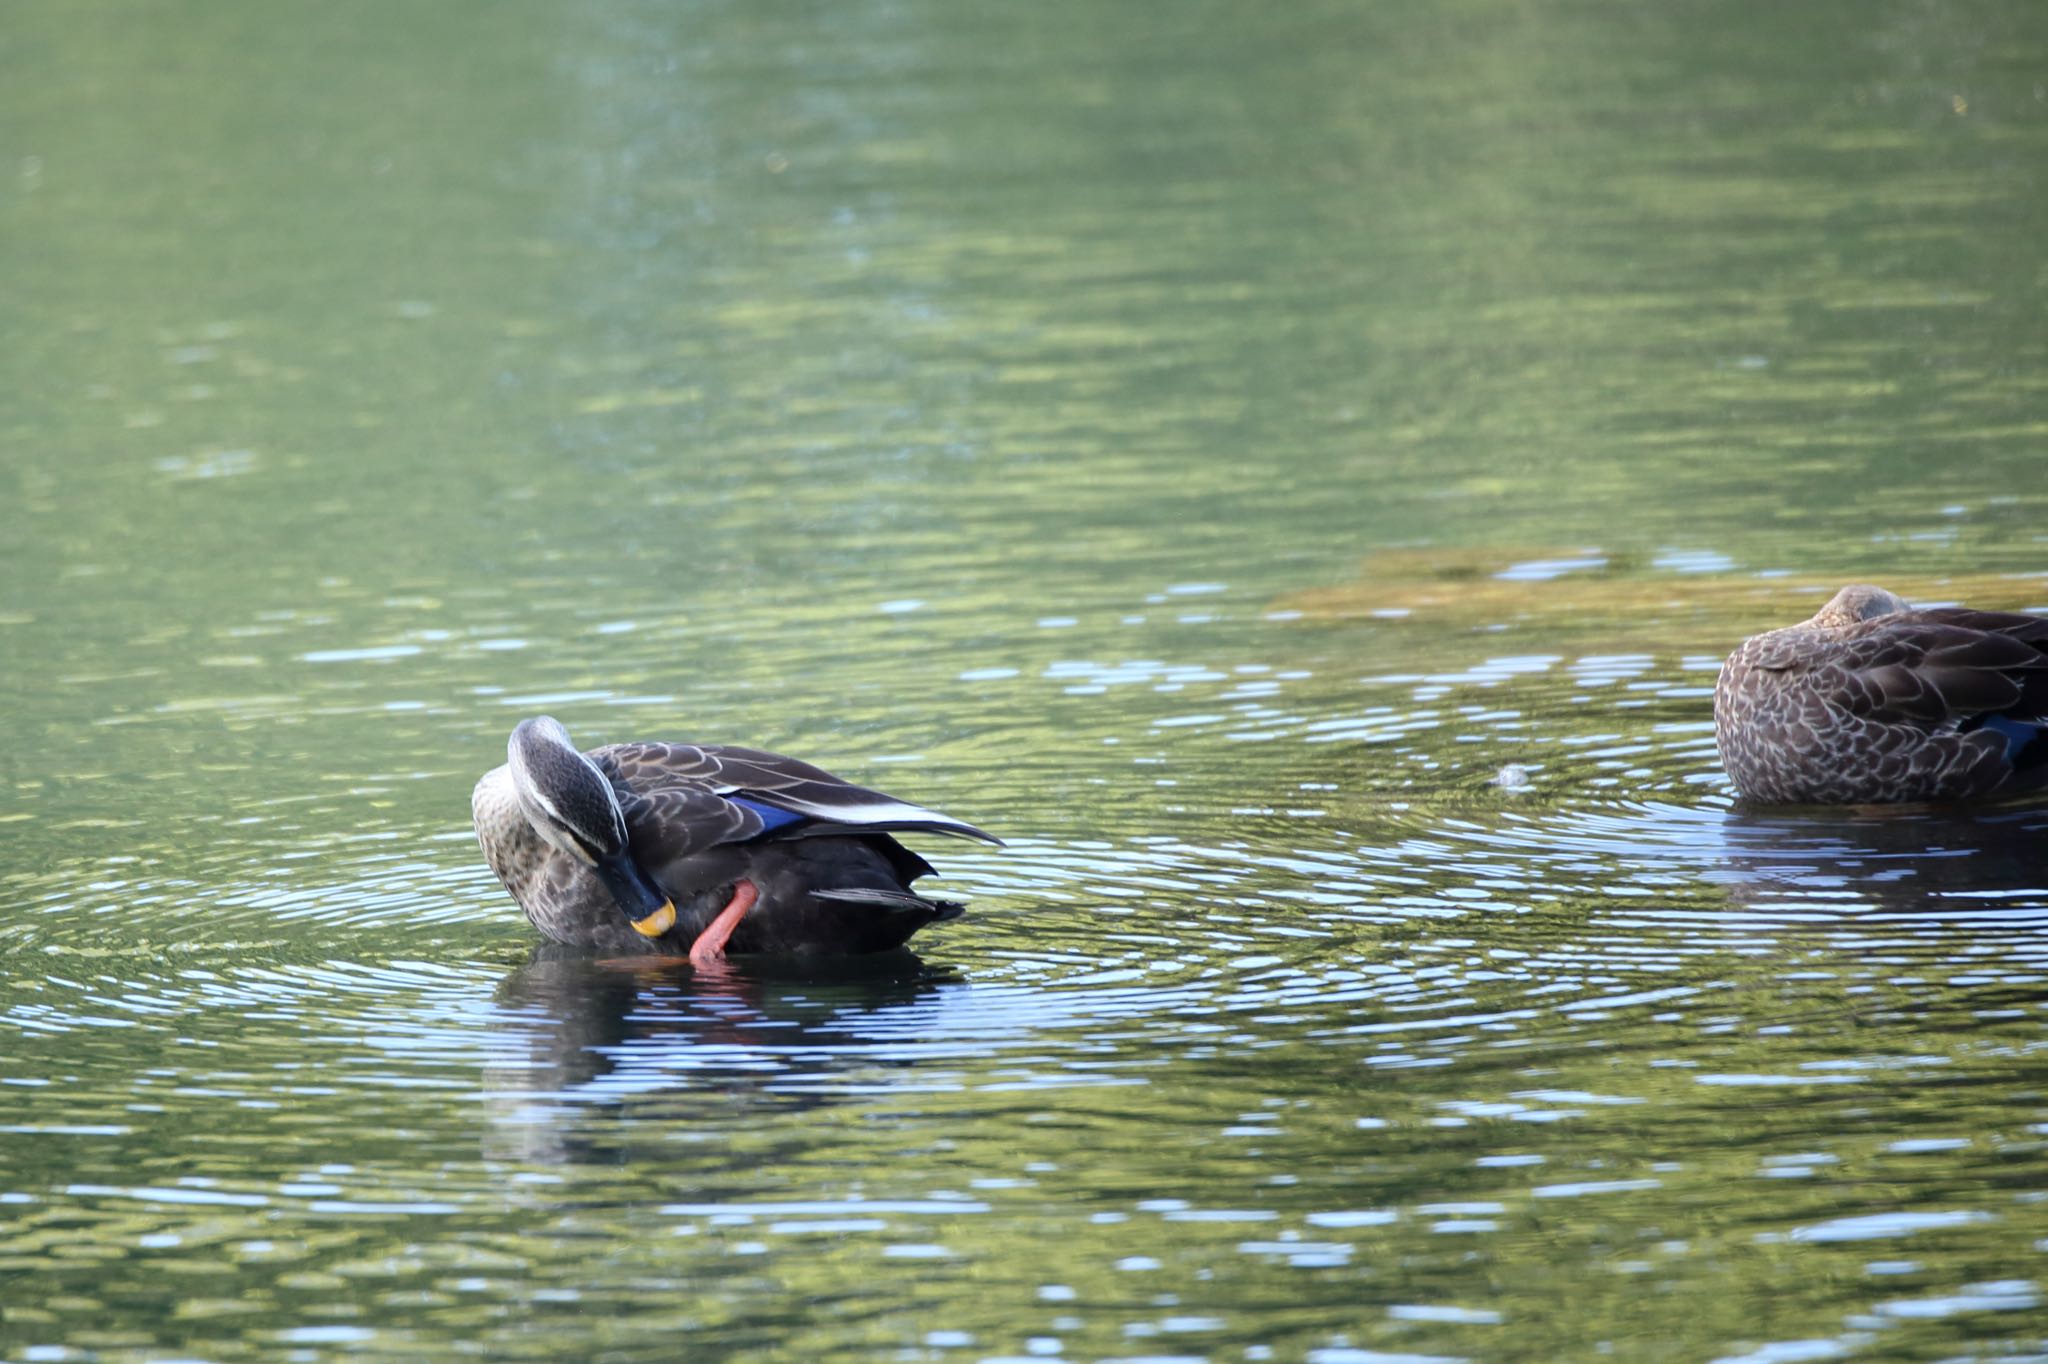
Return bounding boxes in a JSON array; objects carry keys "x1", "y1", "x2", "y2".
[{"x1": 1714, "y1": 584, "x2": 2048, "y2": 805}]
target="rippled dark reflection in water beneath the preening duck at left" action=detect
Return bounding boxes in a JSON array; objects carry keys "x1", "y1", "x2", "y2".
[{"x1": 483, "y1": 944, "x2": 961, "y2": 1163}]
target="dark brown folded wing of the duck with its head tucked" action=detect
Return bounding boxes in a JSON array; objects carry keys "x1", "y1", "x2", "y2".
[{"x1": 1815, "y1": 610, "x2": 2048, "y2": 729}]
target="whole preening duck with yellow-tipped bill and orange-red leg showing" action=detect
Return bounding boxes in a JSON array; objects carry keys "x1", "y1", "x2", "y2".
[{"x1": 469, "y1": 715, "x2": 1001, "y2": 965}]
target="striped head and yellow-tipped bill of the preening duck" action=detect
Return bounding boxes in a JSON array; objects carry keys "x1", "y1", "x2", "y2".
[{"x1": 506, "y1": 715, "x2": 676, "y2": 938}]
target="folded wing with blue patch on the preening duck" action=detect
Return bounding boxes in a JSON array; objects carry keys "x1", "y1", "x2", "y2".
[{"x1": 590, "y1": 743, "x2": 1001, "y2": 844}]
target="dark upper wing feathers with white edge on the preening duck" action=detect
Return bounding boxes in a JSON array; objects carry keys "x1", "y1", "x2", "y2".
[{"x1": 592, "y1": 743, "x2": 1001, "y2": 844}]
